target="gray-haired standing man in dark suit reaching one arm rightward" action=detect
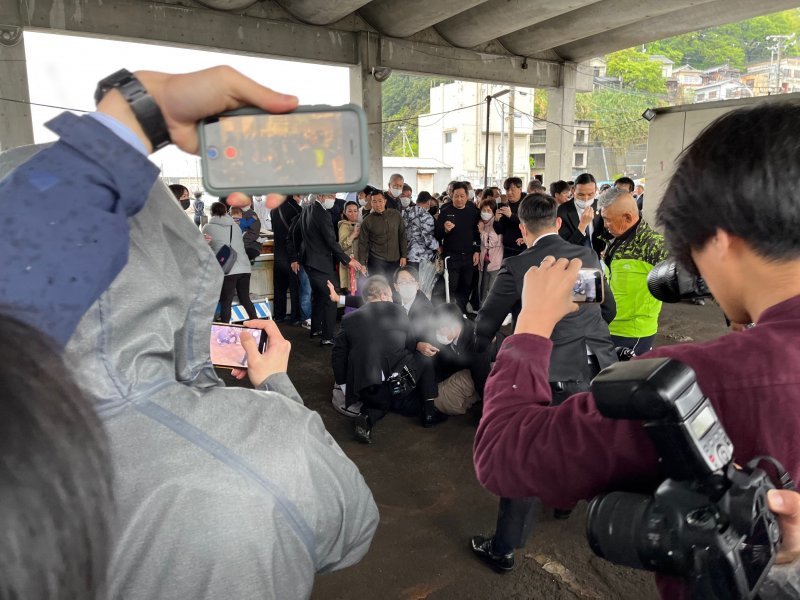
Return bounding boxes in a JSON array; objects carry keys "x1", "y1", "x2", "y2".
[{"x1": 287, "y1": 195, "x2": 364, "y2": 346}]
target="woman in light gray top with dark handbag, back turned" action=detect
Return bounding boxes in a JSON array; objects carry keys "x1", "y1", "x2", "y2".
[{"x1": 203, "y1": 202, "x2": 258, "y2": 323}]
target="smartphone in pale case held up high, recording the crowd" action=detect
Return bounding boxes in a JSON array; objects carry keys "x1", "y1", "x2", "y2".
[{"x1": 198, "y1": 104, "x2": 369, "y2": 196}]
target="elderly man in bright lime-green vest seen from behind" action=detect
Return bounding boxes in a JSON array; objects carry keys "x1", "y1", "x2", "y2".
[{"x1": 602, "y1": 189, "x2": 667, "y2": 355}]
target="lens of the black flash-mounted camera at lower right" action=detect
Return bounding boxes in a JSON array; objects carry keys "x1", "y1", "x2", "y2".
[{"x1": 586, "y1": 492, "x2": 652, "y2": 569}]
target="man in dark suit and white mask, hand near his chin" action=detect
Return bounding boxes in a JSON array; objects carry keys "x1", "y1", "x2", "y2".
[{"x1": 558, "y1": 173, "x2": 606, "y2": 256}]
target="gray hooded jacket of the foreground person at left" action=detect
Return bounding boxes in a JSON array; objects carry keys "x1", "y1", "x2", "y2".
[{"x1": 0, "y1": 143, "x2": 378, "y2": 600}]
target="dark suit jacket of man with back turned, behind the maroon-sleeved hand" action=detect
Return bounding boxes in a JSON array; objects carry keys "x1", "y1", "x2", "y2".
[{"x1": 475, "y1": 235, "x2": 617, "y2": 381}]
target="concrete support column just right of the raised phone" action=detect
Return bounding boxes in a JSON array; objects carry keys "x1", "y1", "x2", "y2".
[{"x1": 350, "y1": 32, "x2": 386, "y2": 189}]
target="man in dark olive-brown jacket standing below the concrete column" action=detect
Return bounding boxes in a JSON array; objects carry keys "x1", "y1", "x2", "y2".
[{"x1": 358, "y1": 190, "x2": 408, "y2": 281}]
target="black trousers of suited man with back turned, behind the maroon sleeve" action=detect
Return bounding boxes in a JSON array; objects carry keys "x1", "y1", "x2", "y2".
[{"x1": 492, "y1": 356, "x2": 600, "y2": 554}]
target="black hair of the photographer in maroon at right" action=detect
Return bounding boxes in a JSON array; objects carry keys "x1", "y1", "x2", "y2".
[{"x1": 656, "y1": 103, "x2": 800, "y2": 269}]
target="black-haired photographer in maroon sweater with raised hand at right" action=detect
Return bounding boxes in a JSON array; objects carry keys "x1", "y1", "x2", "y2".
[{"x1": 474, "y1": 104, "x2": 800, "y2": 600}]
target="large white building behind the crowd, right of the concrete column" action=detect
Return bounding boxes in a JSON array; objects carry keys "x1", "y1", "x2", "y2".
[{"x1": 418, "y1": 81, "x2": 533, "y2": 186}]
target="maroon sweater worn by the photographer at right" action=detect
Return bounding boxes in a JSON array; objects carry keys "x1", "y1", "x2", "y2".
[{"x1": 474, "y1": 296, "x2": 800, "y2": 599}]
